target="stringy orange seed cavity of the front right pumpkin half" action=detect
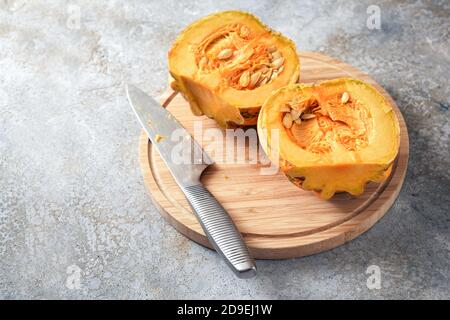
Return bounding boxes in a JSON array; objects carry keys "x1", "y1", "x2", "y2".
[{"x1": 280, "y1": 91, "x2": 373, "y2": 153}]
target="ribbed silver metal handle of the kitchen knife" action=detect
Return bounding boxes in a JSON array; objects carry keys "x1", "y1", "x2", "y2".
[{"x1": 182, "y1": 184, "x2": 256, "y2": 278}]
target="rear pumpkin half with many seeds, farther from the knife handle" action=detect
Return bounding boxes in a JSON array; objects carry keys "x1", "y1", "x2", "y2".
[{"x1": 169, "y1": 11, "x2": 300, "y2": 127}]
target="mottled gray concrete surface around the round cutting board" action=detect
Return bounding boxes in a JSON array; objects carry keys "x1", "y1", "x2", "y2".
[{"x1": 0, "y1": 0, "x2": 450, "y2": 299}]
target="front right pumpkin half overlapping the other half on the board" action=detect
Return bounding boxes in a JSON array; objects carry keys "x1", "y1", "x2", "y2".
[{"x1": 258, "y1": 79, "x2": 400, "y2": 199}]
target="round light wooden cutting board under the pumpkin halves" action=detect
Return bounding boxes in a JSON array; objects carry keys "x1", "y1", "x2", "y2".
[{"x1": 140, "y1": 52, "x2": 409, "y2": 259}]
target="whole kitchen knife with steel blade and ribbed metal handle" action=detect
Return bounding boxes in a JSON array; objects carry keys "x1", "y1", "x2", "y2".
[{"x1": 126, "y1": 85, "x2": 256, "y2": 278}]
